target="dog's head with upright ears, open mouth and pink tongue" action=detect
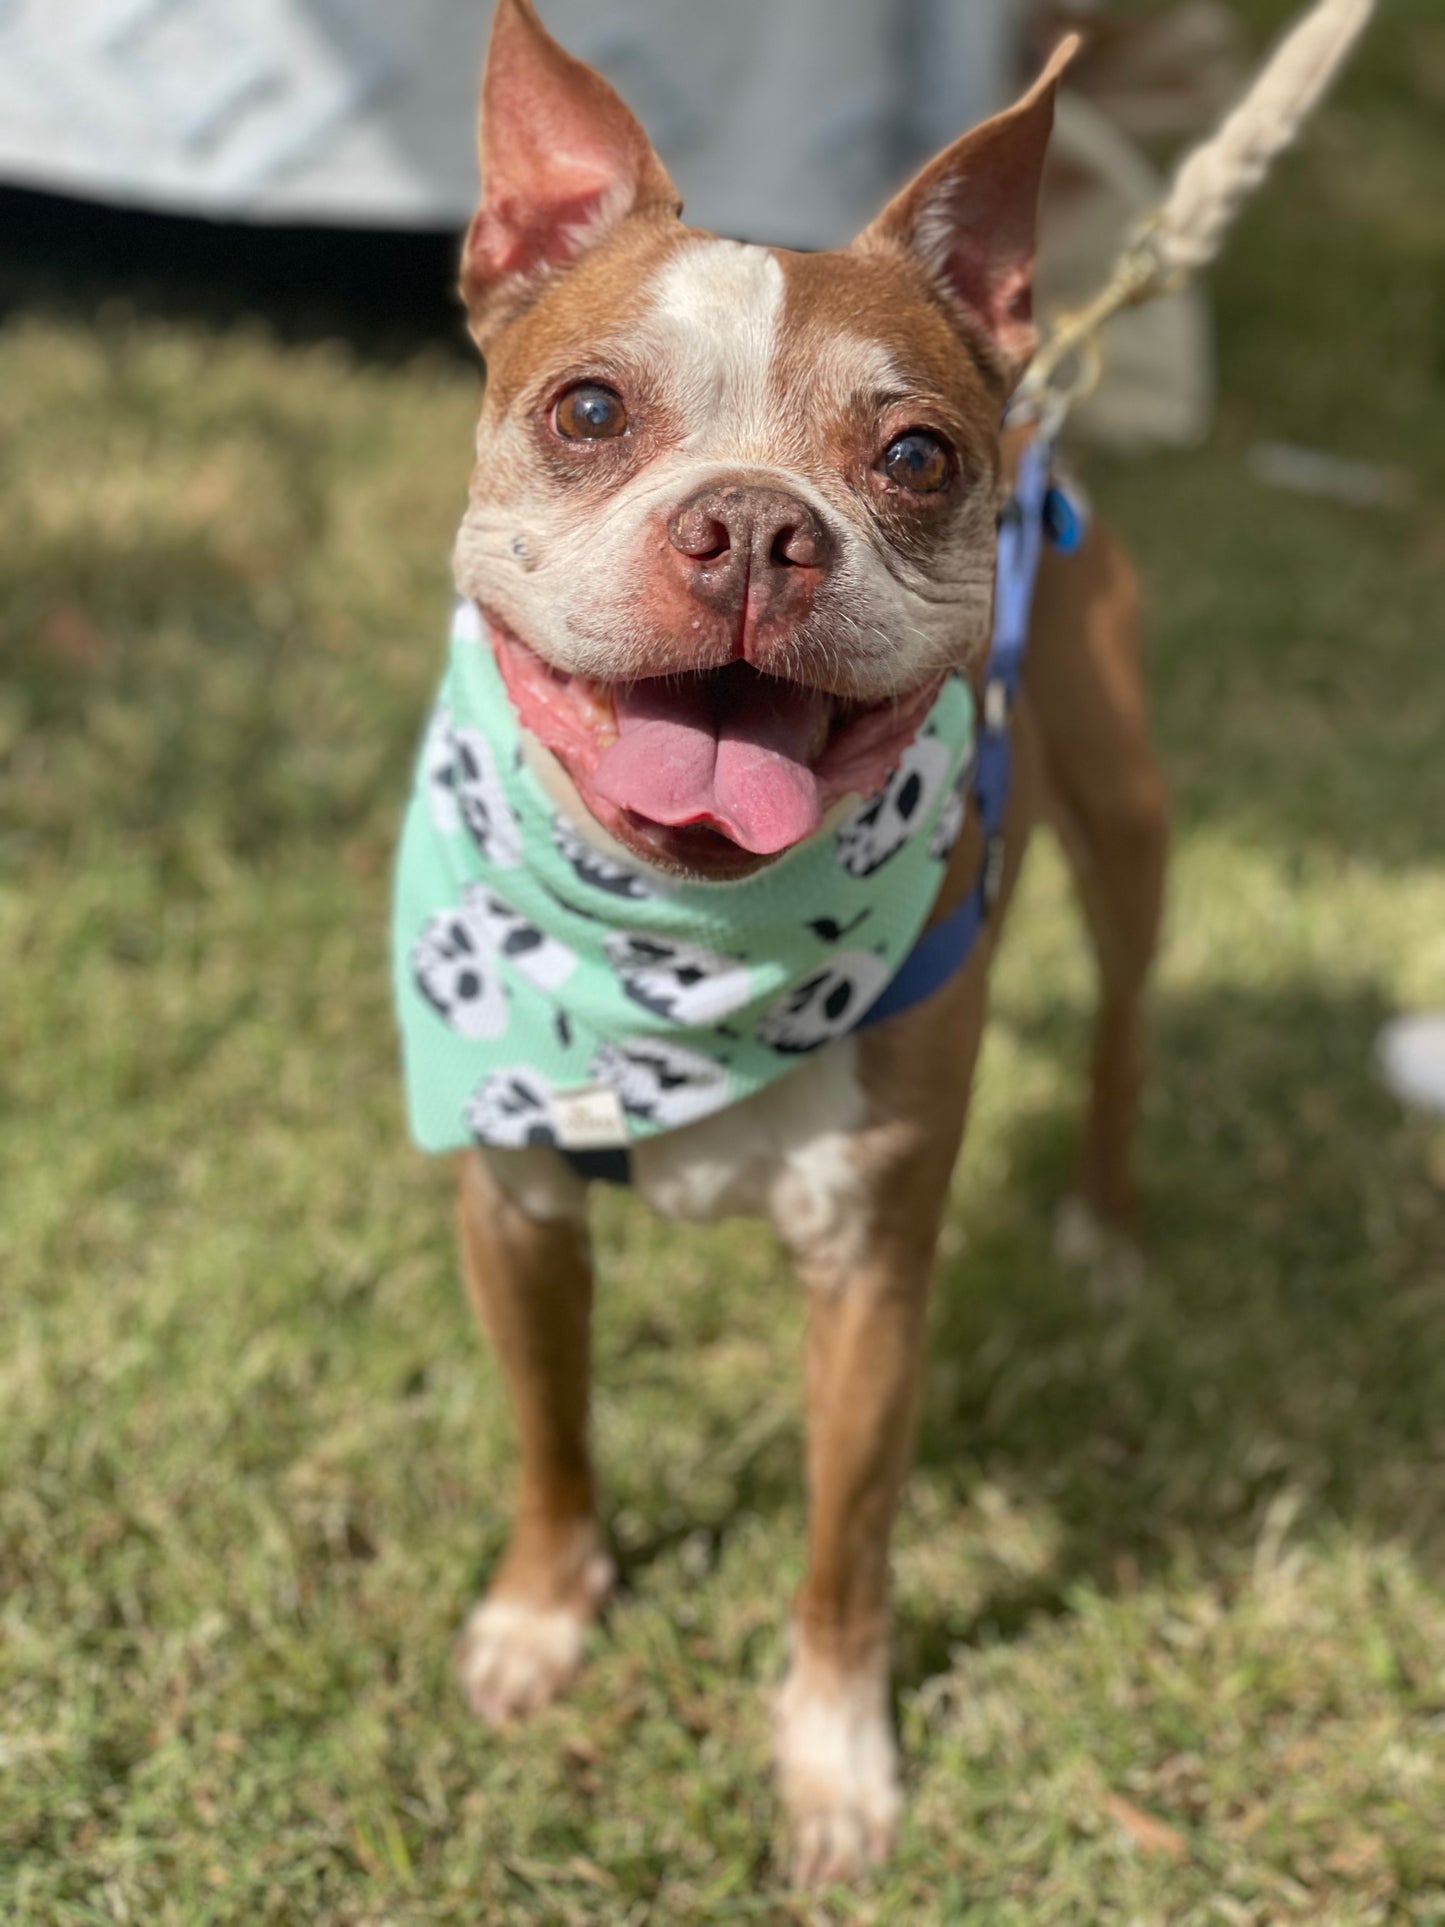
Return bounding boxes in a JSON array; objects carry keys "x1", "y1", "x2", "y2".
[{"x1": 457, "y1": 0, "x2": 1071, "y2": 877}]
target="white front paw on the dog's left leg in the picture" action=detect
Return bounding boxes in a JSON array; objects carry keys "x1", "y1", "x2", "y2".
[{"x1": 457, "y1": 1557, "x2": 613, "y2": 1727}]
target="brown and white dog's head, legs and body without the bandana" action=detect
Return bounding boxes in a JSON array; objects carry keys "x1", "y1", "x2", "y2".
[{"x1": 446, "y1": 0, "x2": 1168, "y2": 1883}]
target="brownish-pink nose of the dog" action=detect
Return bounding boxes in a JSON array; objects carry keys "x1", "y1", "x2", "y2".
[{"x1": 667, "y1": 482, "x2": 832, "y2": 619}]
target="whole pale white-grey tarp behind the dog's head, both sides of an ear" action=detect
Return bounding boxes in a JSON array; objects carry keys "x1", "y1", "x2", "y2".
[{"x1": 0, "y1": 0, "x2": 1010, "y2": 245}]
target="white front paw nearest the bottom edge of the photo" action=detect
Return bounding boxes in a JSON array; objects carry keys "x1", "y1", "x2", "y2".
[{"x1": 776, "y1": 1665, "x2": 902, "y2": 1887}]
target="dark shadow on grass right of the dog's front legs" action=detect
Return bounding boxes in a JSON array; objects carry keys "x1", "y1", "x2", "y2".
[{"x1": 898, "y1": 983, "x2": 1445, "y2": 1684}]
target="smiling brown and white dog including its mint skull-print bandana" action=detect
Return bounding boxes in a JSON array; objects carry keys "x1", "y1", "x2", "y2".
[{"x1": 397, "y1": 0, "x2": 1168, "y2": 1885}]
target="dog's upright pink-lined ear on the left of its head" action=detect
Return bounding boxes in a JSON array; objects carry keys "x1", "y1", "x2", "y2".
[{"x1": 462, "y1": 0, "x2": 682, "y2": 345}]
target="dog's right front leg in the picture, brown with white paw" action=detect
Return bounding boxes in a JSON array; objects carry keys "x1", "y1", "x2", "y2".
[{"x1": 773, "y1": 963, "x2": 988, "y2": 1887}]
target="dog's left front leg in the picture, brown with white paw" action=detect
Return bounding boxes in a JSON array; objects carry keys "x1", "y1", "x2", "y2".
[{"x1": 459, "y1": 1152, "x2": 613, "y2": 1725}]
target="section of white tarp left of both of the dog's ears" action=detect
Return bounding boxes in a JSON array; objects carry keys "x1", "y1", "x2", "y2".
[{"x1": 0, "y1": 0, "x2": 486, "y2": 225}]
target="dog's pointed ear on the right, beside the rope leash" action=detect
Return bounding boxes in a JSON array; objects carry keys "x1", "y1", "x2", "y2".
[{"x1": 854, "y1": 35, "x2": 1079, "y2": 387}]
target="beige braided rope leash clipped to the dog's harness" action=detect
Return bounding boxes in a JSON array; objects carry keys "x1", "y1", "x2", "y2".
[{"x1": 1017, "y1": 0, "x2": 1374, "y2": 420}]
